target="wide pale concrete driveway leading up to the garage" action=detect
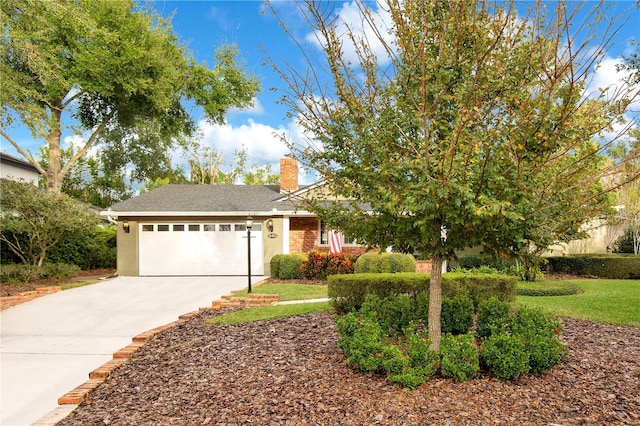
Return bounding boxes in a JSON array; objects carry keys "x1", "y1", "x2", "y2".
[{"x1": 0, "y1": 277, "x2": 264, "y2": 426}]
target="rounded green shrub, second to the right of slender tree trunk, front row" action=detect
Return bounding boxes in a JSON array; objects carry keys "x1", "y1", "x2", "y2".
[{"x1": 482, "y1": 334, "x2": 529, "y2": 380}]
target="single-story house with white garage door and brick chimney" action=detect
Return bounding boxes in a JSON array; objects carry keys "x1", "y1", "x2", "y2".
[{"x1": 102, "y1": 157, "x2": 363, "y2": 276}]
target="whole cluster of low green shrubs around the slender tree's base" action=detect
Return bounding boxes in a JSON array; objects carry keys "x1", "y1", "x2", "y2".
[{"x1": 336, "y1": 292, "x2": 567, "y2": 388}]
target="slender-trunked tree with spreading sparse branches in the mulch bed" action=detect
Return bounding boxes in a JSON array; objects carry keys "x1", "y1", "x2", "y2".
[{"x1": 276, "y1": 0, "x2": 638, "y2": 349}]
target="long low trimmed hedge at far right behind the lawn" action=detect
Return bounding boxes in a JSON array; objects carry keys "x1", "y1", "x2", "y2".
[{"x1": 547, "y1": 255, "x2": 640, "y2": 280}]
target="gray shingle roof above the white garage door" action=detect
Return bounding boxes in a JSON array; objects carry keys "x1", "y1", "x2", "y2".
[{"x1": 110, "y1": 185, "x2": 294, "y2": 214}]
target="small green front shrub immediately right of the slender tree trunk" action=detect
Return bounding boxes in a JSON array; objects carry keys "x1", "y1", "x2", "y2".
[{"x1": 440, "y1": 333, "x2": 480, "y2": 382}]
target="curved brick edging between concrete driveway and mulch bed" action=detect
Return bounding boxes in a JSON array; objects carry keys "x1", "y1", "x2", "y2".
[{"x1": 32, "y1": 283, "x2": 279, "y2": 426}]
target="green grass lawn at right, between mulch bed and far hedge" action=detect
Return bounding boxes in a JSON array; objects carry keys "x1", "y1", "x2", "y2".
[{"x1": 516, "y1": 279, "x2": 640, "y2": 326}]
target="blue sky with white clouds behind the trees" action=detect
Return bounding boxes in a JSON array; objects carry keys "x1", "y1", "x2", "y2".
[{"x1": 0, "y1": 0, "x2": 640, "y2": 183}]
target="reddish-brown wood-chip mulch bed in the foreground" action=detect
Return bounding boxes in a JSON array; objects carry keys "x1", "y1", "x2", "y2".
[{"x1": 58, "y1": 311, "x2": 640, "y2": 425}]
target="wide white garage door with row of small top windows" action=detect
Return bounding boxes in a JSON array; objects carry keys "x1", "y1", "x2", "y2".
[{"x1": 138, "y1": 222, "x2": 264, "y2": 275}]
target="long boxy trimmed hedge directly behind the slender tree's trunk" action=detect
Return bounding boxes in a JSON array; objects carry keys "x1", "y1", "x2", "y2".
[{"x1": 327, "y1": 272, "x2": 518, "y2": 313}]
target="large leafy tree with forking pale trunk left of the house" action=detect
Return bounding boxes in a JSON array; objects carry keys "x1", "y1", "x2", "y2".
[{"x1": 0, "y1": 0, "x2": 258, "y2": 192}]
